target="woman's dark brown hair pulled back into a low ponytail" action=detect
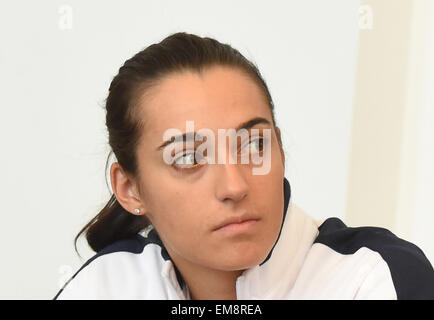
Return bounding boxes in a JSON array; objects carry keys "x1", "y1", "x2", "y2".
[{"x1": 74, "y1": 32, "x2": 276, "y2": 253}]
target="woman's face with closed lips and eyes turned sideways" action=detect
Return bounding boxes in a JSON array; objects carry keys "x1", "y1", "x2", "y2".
[{"x1": 133, "y1": 66, "x2": 284, "y2": 270}]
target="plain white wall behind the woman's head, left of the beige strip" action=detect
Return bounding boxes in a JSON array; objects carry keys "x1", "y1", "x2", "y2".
[{"x1": 0, "y1": 0, "x2": 431, "y2": 299}]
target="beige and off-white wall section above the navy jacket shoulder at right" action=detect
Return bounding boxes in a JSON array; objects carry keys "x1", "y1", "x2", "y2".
[{"x1": 345, "y1": 0, "x2": 434, "y2": 270}]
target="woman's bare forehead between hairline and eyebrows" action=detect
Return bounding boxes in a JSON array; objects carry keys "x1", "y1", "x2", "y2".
[{"x1": 139, "y1": 66, "x2": 271, "y2": 144}]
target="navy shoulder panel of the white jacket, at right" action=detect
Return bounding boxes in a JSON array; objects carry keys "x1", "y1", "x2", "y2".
[{"x1": 314, "y1": 217, "x2": 434, "y2": 299}]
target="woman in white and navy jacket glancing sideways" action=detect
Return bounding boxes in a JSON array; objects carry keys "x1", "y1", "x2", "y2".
[{"x1": 55, "y1": 33, "x2": 434, "y2": 299}]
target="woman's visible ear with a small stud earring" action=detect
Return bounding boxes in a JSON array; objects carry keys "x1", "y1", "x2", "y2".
[{"x1": 110, "y1": 162, "x2": 146, "y2": 215}]
